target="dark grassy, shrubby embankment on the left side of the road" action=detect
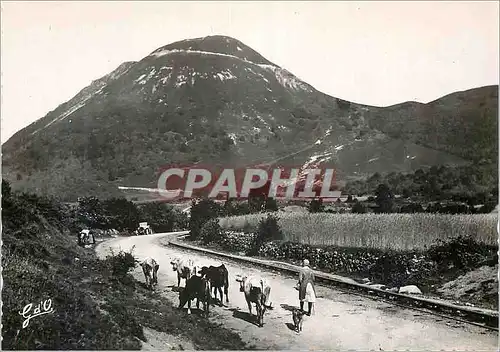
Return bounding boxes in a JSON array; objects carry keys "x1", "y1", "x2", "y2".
[{"x1": 2, "y1": 181, "x2": 246, "y2": 350}]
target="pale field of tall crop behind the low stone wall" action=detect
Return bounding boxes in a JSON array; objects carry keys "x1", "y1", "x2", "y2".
[{"x1": 219, "y1": 212, "x2": 498, "y2": 250}]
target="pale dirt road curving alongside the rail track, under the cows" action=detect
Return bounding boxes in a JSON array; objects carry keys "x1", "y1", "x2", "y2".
[{"x1": 97, "y1": 233, "x2": 498, "y2": 351}]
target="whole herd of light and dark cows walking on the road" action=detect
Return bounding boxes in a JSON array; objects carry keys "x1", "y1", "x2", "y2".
[{"x1": 141, "y1": 258, "x2": 272, "y2": 327}]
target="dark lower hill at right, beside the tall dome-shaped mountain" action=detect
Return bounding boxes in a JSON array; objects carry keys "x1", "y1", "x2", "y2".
[{"x1": 362, "y1": 86, "x2": 498, "y2": 162}]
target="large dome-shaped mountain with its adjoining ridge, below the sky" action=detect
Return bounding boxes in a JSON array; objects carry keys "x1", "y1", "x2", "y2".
[{"x1": 2, "y1": 36, "x2": 498, "y2": 200}]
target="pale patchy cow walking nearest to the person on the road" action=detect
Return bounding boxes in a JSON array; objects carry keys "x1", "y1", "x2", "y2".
[{"x1": 236, "y1": 276, "x2": 272, "y2": 327}]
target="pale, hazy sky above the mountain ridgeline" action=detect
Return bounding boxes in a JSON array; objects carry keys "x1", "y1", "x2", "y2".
[{"x1": 1, "y1": 1, "x2": 499, "y2": 143}]
